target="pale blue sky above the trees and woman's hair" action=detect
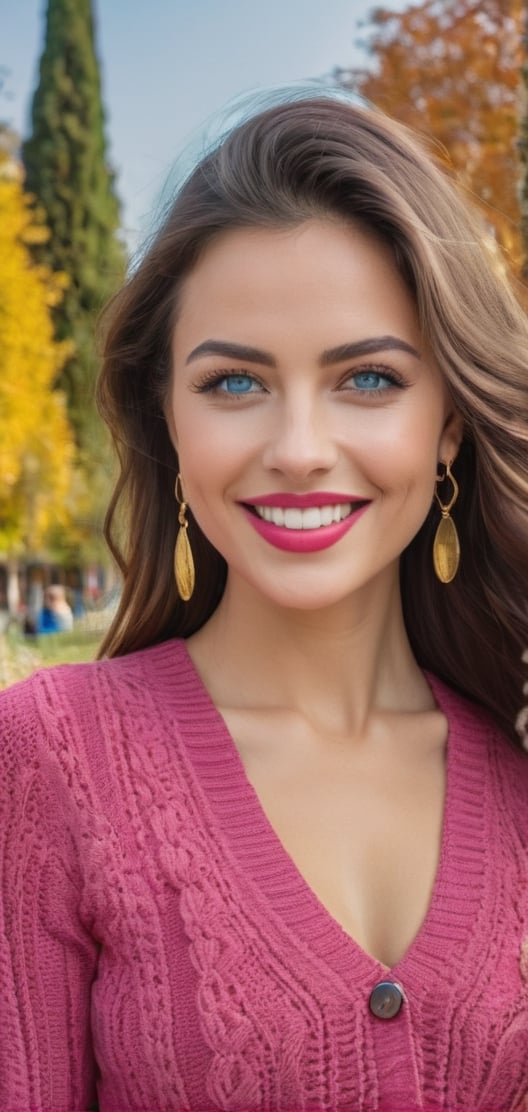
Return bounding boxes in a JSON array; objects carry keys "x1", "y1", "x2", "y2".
[{"x1": 0, "y1": 0, "x2": 408, "y2": 248}]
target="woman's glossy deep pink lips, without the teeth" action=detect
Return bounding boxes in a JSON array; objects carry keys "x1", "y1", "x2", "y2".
[{"x1": 240, "y1": 490, "x2": 370, "y2": 553}]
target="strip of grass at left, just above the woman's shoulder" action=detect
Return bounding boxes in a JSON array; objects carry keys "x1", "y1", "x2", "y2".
[{"x1": 0, "y1": 628, "x2": 101, "y2": 688}]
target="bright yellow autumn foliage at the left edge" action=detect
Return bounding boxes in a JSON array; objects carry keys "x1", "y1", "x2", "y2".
[{"x1": 0, "y1": 147, "x2": 73, "y2": 555}]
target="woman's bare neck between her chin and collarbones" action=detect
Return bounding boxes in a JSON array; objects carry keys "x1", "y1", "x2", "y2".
[{"x1": 188, "y1": 564, "x2": 434, "y2": 731}]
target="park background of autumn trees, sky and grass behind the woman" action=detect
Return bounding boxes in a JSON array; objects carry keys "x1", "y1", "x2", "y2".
[{"x1": 0, "y1": 0, "x2": 528, "y2": 686}]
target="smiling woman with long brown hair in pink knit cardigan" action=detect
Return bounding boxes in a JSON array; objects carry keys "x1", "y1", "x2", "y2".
[{"x1": 0, "y1": 98, "x2": 528, "y2": 1112}]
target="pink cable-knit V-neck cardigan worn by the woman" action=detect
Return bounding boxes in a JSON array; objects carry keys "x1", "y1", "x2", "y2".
[{"x1": 0, "y1": 642, "x2": 528, "y2": 1112}]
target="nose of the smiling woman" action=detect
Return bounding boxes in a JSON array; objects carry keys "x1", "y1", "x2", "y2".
[{"x1": 263, "y1": 397, "x2": 338, "y2": 480}]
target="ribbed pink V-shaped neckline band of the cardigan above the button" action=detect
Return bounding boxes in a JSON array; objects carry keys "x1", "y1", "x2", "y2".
[{"x1": 164, "y1": 642, "x2": 486, "y2": 984}]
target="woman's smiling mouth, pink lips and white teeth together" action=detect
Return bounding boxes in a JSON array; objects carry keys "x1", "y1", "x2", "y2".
[{"x1": 240, "y1": 495, "x2": 370, "y2": 553}]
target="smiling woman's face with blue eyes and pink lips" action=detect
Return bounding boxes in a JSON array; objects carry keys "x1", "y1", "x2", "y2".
[{"x1": 166, "y1": 219, "x2": 461, "y2": 609}]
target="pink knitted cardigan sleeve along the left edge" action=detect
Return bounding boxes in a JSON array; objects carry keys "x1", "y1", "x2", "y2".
[{"x1": 0, "y1": 675, "x2": 98, "y2": 1112}]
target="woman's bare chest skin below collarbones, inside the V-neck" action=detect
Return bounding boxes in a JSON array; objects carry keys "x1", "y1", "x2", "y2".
[{"x1": 221, "y1": 715, "x2": 446, "y2": 966}]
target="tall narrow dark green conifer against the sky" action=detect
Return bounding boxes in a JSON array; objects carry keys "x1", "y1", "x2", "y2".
[{"x1": 22, "y1": 0, "x2": 123, "y2": 453}]
